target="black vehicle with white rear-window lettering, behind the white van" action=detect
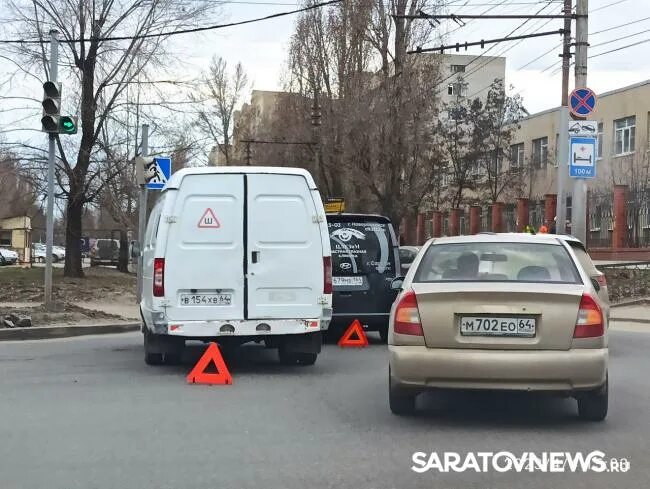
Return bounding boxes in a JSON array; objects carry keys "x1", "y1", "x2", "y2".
[{"x1": 327, "y1": 214, "x2": 402, "y2": 341}]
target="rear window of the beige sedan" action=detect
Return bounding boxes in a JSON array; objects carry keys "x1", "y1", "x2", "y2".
[{"x1": 414, "y1": 242, "x2": 582, "y2": 284}]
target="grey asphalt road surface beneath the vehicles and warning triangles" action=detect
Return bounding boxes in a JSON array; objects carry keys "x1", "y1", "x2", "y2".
[{"x1": 0, "y1": 332, "x2": 650, "y2": 489}]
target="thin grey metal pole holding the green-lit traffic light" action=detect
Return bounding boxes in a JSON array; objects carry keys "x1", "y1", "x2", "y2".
[{"x1": 45, "y1": 30, "x2": 59, "y2": 311}]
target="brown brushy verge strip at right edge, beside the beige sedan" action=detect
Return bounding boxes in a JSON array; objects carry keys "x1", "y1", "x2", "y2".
[{"x1": 596, "y1": 262, "x2": 650, "y2": 303}]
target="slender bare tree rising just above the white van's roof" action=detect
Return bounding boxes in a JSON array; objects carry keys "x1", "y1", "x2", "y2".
[{"x1": 191, "y1": 56, "x2": 248, "y2": 165}]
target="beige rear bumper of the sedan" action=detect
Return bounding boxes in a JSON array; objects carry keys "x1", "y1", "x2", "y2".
[{"x1": 388, "y1": 345, "x2": 608, "y2": 392}]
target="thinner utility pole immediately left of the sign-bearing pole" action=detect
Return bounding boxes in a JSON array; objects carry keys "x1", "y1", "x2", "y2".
[{"x1": 555, "y1": 0, "x2": 573, "y2": 234}]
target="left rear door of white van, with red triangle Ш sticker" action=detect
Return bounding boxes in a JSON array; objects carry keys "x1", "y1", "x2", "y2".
[{"x1": 161, "y1": 174, "x2": 245, "y2": 321}]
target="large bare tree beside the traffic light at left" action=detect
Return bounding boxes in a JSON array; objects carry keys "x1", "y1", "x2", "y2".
[{"x1": 3, "y1": 0, "x2": 216, "y2": 277}]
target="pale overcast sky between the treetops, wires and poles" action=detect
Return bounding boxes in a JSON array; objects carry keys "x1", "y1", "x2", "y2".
[{"x1": 0, "y1": 0, "x2": 650, "y2": 139}]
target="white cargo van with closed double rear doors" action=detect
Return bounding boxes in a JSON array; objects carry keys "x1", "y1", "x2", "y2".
[{"x1": 140, "y1": 167, "x2": 332, "y2": 365}]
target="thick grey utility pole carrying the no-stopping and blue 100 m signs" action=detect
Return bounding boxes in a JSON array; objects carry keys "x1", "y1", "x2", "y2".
[{"x1": 571, "y1": 0, "x2": 595, "y2": 245}]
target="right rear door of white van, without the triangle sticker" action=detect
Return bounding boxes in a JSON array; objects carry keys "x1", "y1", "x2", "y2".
[{"x1": 247, "y1": 174, "x2": 325, "y2": 319}]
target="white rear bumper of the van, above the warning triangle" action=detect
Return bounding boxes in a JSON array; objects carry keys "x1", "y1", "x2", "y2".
[{"x1": 156, "y1": 318, "x2": 321, "y2": 338}]
